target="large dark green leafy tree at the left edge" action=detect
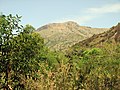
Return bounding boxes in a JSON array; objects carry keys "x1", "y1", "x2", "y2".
[{"x1": 0, "y1": 15, "x2": 45, "y2": 90}]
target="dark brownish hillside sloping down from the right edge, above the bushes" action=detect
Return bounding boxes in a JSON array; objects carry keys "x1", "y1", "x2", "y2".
[{"x1": 73, "y1": 23, "x2": 120, "y2": 47}]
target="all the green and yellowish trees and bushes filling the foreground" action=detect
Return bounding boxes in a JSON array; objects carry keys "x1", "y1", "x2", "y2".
[{"x1": 0, "y1": 15, "x2": 120, "y2": 90}]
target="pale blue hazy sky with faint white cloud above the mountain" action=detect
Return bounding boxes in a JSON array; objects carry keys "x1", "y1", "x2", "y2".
[{"x1": 0, "y1": 0, "x2": 120, "y2": 28}]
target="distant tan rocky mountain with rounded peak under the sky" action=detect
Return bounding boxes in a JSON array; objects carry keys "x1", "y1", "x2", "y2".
[{"x1": 36, "y1": 21, "x2": 108, "y2": 50}]
